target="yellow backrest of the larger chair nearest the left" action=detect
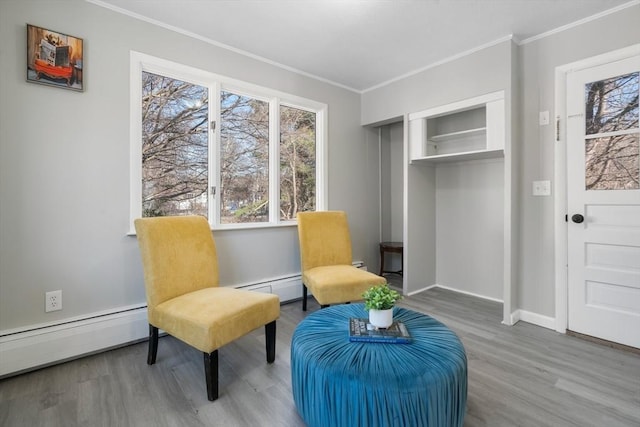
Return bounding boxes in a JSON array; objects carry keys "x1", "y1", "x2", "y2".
[{"x1": 135, "y1": 215, "x2": 219, "y2": 311}]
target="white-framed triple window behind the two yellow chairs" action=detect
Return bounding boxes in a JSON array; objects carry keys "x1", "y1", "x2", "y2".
[{"x1": 130, "y1": 52, "x2": 326, "y2": 228}]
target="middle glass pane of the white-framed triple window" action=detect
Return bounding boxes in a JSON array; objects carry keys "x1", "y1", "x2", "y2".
[{"x1": 220, "y1": 91, "x2": 269, "y2": 224}]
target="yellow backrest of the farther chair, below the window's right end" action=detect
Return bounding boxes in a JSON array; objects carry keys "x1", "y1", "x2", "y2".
[{"x1": 297, "y1": 211, "x2": 352, "y2": 272}]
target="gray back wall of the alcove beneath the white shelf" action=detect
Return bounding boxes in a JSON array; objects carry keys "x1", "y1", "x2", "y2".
[{"x1": 435, "y1": 159, "x2": 504, "y2": 300}]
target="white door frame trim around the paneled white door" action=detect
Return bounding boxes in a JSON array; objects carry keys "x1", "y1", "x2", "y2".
[{"x1": 553, "y1": 43, "x2": 640, "y2": 334}]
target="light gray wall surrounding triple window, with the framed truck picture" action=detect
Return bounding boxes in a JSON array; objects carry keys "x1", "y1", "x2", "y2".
[{"x1": 0, "y1": 0, "x2": 379, "y2": 331}]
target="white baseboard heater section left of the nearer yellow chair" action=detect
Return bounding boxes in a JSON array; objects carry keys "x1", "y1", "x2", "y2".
[{"x1": 0, "y1": 306, "x2": 149, "y2": 378}]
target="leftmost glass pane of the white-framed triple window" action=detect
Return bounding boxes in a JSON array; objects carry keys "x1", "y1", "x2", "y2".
[{"x1": 142, "y1": 72, "x2": 209, "y2": 217}]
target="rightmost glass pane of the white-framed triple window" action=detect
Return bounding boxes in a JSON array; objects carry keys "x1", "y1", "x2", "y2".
[{"x1": 280, "y1": 106, "x2": 316, "y2": 221}]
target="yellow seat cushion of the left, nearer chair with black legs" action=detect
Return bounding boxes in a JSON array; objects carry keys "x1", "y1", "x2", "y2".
[{"x1": 149, "y1": 287, "x2": 280, "y2": 353}]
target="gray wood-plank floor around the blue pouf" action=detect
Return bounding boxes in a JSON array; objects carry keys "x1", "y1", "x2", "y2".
[{"x1": 0, "y1": 289, "x2": 640, "y2": 427}]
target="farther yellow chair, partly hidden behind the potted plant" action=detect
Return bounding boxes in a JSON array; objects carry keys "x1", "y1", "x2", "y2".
[{"x1": 297, "y1": 211, "x2": 386, "y2": 311}]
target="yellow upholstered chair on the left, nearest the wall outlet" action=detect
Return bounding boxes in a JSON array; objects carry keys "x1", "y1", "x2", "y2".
[{"x1": 135, "y1": 216, "x2": 280, "y2": 400}]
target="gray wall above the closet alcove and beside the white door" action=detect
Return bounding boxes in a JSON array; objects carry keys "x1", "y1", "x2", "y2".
[{"x1": 361, "y1": 5, "x2": 640, "y2": 317}]
